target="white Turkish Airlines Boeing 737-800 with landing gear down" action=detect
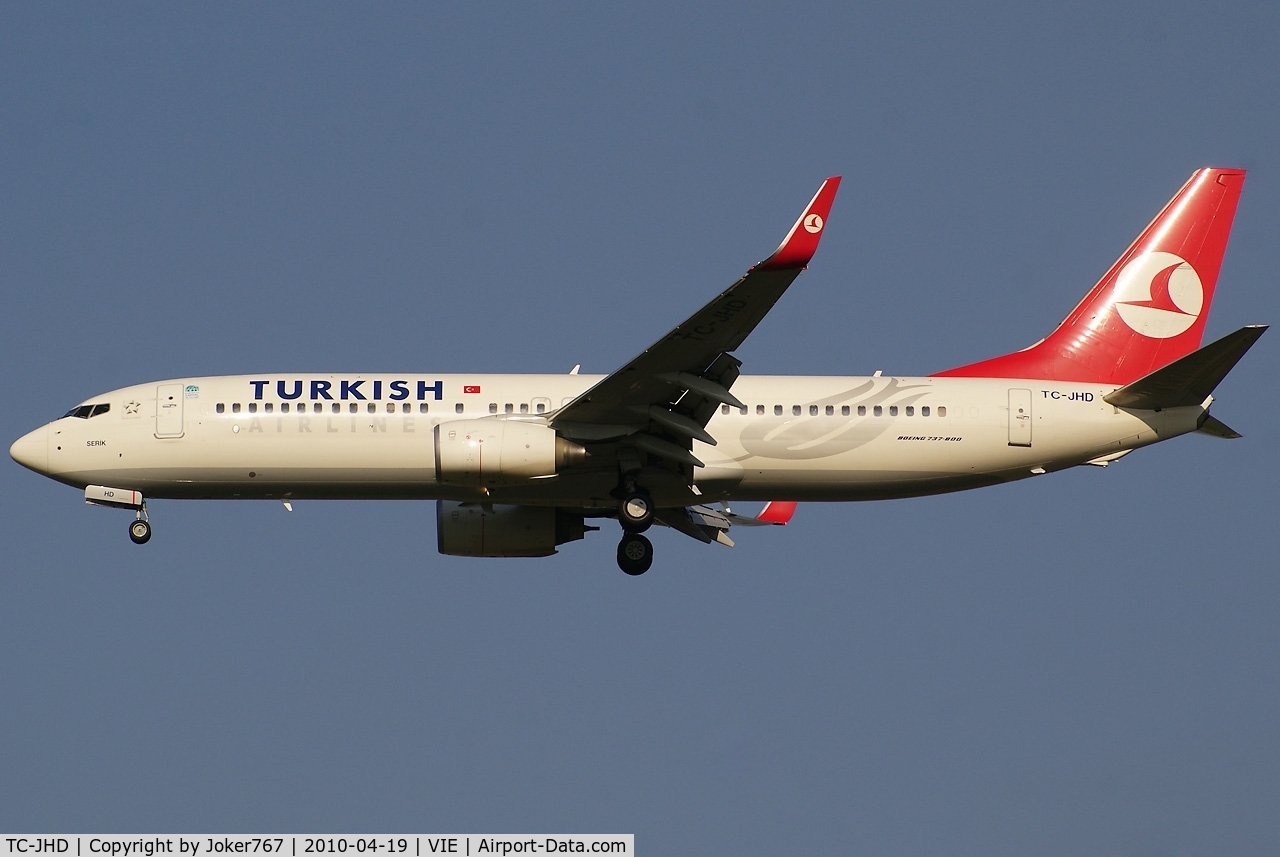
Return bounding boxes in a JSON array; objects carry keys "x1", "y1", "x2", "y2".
[{"x1": 9, "y1": 168, "x2": 1266, "y2": 576}]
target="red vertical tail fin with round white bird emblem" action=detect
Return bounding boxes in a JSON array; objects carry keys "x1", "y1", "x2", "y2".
[{"x1": 937, "y1": 168, "x2": 1244, "y2": 384}]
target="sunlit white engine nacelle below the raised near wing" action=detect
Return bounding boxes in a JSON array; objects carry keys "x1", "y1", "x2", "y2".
[{"x1": 435, "y1": 420, "x2": 586, "y2": 486}]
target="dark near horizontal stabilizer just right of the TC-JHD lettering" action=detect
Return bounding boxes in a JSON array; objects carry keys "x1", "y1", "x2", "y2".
[{"x1": 1103, "y1": 325, "x2": 1267, "y2": 411}]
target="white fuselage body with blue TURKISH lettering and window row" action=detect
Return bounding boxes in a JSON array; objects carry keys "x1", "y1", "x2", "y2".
[{"x1": 23, "y1": 375, "x2": 1203, "y2": 508}]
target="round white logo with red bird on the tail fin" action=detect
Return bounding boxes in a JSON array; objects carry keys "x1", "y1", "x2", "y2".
[{"x1": 1115, "y1": 251, "x2": 1204, "y2": 339}]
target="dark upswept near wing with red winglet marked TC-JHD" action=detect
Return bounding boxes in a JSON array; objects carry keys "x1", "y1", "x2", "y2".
[{"x1": 550, "y1": 175, "x2": 840, "y2": 455}]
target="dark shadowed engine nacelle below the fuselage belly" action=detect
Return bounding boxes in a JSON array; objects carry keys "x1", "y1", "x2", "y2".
[{"x1": 435, "y1": 500, "x2": 586, "y2": 556}]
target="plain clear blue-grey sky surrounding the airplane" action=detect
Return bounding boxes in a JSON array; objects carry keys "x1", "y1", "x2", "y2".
[{"x1": 0, "y1": 3, "x2": 1280, "y2": 854}]
